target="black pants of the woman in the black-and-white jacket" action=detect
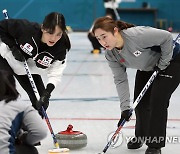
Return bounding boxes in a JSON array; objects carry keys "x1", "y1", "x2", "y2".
[{"x1": 0, "y1": 56, "x2": 45, "y2": 108}]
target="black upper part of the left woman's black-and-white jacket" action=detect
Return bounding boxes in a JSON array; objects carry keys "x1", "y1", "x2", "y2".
[{"x1": 0, "y1": 19, "x2": 68, "y2": 68}]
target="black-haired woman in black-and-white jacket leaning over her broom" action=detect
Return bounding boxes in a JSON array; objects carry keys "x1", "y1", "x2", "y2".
[{"x1": 0, "y1": 12, "x2": 71, "y2": 114}]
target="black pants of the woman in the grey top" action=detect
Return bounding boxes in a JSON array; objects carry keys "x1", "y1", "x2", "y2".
[{"x1": 134, "y1": 55, "x2": 180, "y2": 148}]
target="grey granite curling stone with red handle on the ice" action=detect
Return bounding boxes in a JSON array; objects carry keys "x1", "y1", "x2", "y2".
[{"x1": 56, "y1": 125, "x2": 87, "y2": 149}]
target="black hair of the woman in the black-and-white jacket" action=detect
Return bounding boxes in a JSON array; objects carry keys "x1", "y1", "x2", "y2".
[{"x1": 42, "y1": 12, "x2": 71, "y2": 50}]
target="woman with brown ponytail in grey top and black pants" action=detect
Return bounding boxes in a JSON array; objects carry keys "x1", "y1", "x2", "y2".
[{"x1": 92, "y1": 17, "x2": 180, "y2": 154}]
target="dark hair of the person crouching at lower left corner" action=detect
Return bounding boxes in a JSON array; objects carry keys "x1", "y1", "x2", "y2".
[{"x1": 0, "y1": 70, "x2": 19, "y2": 103}]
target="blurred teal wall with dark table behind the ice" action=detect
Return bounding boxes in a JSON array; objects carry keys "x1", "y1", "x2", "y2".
[{"x1": 0, "y1": 0, "x2": 180, "y2": 32}]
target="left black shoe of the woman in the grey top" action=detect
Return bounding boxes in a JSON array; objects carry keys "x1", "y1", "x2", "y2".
[{"x1": 127, "y1": 137, "x2": 144, "y2": 149}]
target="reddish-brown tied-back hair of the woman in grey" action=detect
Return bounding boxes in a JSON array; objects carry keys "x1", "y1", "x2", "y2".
[{"x1": 92, "y1": 17, "x2": 135, "y2": 34}]
